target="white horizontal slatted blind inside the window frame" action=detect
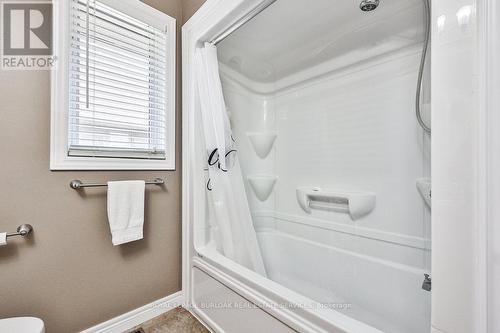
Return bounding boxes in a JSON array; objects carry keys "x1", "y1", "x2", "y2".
[{"x1": 68, "y1": 0, "x2": 168, "y2": 159}]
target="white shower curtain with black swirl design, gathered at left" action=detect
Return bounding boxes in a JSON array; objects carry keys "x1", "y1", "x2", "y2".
[{"x1": 196, "y1": 43, "x2": 266, "y2": 276}]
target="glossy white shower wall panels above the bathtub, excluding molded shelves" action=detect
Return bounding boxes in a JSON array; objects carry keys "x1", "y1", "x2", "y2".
[{"x1": 222, "y1": 45, "x2": 430, "y2": 236}]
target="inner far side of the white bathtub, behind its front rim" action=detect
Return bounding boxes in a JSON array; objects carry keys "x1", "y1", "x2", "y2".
[{"x1": 258, "y1": 231, "x2": 430, "y2": 333}]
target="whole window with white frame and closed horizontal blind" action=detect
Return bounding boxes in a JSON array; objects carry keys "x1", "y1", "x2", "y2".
[{"x1": 51, "y1": 0, "x2": 175, "y2": 170}]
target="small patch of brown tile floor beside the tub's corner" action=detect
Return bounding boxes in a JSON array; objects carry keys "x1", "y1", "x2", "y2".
[{"x1": 127, "y1": 307, "x2": 209, "y2": 333}]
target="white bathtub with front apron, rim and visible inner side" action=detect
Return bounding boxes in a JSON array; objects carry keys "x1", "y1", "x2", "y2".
[{"x1": 192, "y1": 228, "x2": 430, "y2": 333}]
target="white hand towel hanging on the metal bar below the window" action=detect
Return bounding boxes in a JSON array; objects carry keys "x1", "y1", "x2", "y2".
[{"x1": 108, "y1": 180, "x2": 145, "y2": 245}]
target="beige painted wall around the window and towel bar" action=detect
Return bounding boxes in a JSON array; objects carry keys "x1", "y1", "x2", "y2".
[{"x1": 0, "y1": 0, "x2": 186, "y2": 333}]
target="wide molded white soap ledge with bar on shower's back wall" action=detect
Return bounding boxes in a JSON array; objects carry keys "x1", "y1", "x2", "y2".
[{"x1": 296, "y1": 187, "x2": 375, "y2": 221}]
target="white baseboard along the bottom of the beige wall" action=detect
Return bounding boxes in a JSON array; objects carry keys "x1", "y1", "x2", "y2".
[{"x1": 80, "y1": 291, "x2": 184, "y2": 333}]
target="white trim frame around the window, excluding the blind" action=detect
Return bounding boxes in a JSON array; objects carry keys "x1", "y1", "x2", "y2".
[{"x1": 50, "y1": 0, "x2": 176, "y2": 170}]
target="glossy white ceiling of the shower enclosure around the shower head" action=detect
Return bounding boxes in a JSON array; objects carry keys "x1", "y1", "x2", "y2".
[{"x1": 218, "y1": 0, "x2": 424, "y2": 83}]
